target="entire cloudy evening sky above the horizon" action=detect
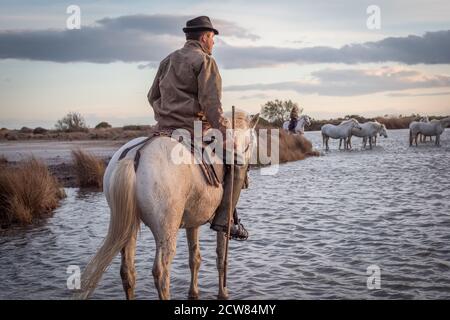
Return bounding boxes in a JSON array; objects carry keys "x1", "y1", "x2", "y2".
[{"x1": 0, "y1": 0, "x2": 450, "y2": 128}]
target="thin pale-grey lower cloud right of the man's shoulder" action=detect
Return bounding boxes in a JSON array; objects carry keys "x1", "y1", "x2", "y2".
[{"x1": 224, "y1": 67, "x2": 450, "y2": 96}]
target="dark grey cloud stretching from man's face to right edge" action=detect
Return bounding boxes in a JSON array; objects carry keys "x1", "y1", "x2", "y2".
[{"x1": 216, "y1": 30, "x2": 450, "y2": 68}]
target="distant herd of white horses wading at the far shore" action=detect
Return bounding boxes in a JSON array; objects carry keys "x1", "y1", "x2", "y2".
[{"x1": 283, "y1": 115, "x2": 450, "y2": 151}]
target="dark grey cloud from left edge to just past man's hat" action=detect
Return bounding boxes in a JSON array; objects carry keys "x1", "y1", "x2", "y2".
[{"x1": 0, "y1": 15, "x2": 257, "y2": 63}]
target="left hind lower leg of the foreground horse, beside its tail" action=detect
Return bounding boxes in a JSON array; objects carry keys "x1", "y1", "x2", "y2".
[{"x1": 120, "y1": 228, "x2": 137, "y2": 300}]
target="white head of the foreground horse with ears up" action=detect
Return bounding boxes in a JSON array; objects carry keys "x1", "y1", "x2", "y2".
[{"x1": 227, "y1": 110, "x2": 259, "y2": 164}]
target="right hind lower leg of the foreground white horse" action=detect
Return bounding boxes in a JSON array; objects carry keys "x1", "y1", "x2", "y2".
[{"x1": 152, "y1": 232, "x2": 177, "y2": 300}]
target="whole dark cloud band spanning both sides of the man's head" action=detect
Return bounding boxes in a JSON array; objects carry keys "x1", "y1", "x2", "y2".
[{"x1": 0, "y1": 15, "x2": 450, "y2": 69}]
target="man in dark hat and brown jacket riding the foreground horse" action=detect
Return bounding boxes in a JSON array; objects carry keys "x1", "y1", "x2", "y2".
[{"x1": 148, "y1": 16, "x2": 248, "y2": 240}]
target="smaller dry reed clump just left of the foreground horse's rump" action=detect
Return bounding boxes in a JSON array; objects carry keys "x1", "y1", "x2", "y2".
[{"x1": 72, "y1": 150, "x2": 105, "y2": 188}]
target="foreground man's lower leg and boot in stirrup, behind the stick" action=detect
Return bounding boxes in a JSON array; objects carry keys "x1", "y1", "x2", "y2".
[{"x1": 211, "y1": 164, "x2": 248, "y2": 240}]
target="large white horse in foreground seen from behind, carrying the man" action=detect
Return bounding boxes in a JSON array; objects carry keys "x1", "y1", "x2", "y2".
[{"x1": 78, "y1": 111, "x2": 259, "y2": 299}]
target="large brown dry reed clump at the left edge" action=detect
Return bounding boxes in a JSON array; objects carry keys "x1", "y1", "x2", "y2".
[{"x1": 0, "y1": 158, "x2": 65, "y2": 226}]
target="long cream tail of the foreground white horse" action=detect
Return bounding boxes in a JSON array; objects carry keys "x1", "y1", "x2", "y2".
[{"x1": 77, "y1": 159, "x2": 140, "y2": 299}]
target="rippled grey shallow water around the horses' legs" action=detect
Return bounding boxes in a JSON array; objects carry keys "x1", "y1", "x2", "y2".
[{"x1": 0, "y1": 130, "x2": 450, "y2": 299}]
